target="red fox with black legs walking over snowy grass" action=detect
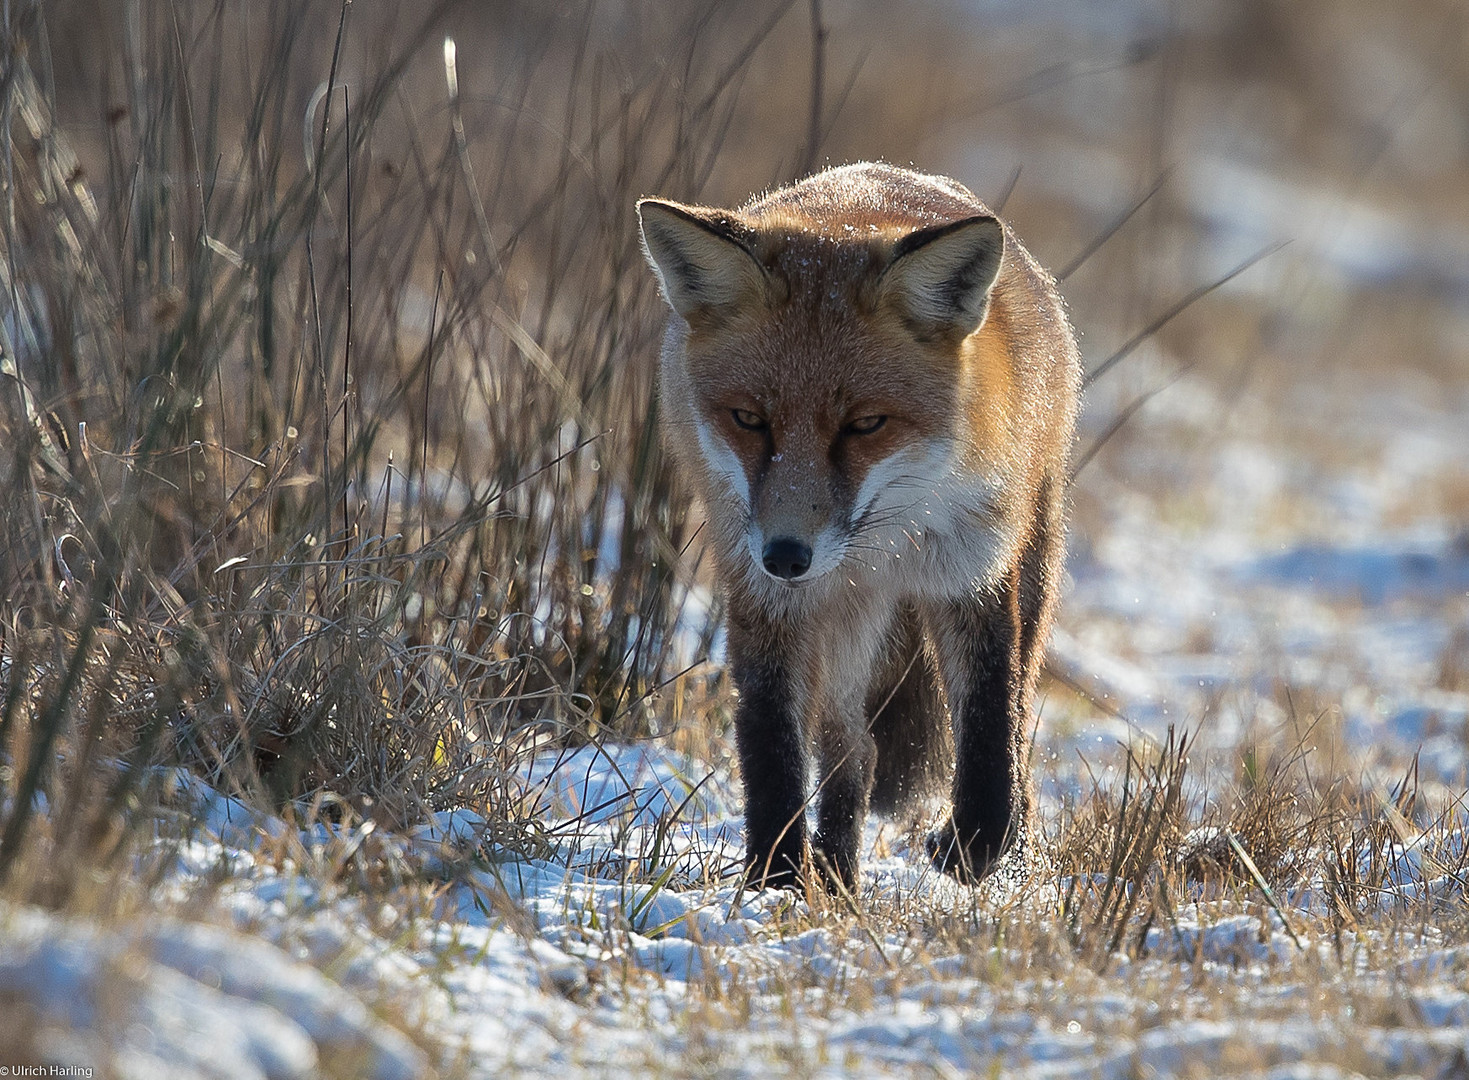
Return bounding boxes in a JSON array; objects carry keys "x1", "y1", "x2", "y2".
[{"x1": 638, "y1": 163, "x2": 1081, "y2": 890}]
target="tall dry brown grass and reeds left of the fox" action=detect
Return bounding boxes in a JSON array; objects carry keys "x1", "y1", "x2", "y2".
[{"x1": 0, "y1": 4, "x2": 828, "y2": 899}]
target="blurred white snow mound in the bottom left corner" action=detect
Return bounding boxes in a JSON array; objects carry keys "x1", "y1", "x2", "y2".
[{"x1": 0, "y1": 908, "x2": 390, "y2": 1080}]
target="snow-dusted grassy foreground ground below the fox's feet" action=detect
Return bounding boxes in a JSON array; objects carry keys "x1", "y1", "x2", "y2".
[{"x1": 0, "y1": 731, "x2": 1469, "y2": 1079}]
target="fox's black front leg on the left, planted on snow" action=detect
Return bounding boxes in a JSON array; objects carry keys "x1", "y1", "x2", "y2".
[{"x1": 730, "y1": 610, "x2": 806, "y2": 889}]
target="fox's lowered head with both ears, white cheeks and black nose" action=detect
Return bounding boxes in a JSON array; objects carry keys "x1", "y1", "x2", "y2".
[{"x1": 638, "y1": 186, "x2": 1005, "y2": 586}]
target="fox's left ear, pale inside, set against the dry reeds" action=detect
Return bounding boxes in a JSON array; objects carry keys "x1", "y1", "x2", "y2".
[{"x1": 638, "y1": 198, "x2": 767, "y2": 322}]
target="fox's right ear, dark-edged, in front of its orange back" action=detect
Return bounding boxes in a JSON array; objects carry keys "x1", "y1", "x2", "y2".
[{"x1": 878, "y1": 213, "x2": 1005, "y2": 338}]
